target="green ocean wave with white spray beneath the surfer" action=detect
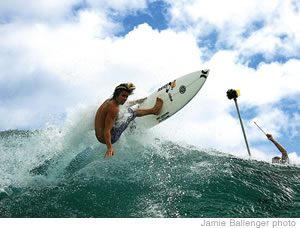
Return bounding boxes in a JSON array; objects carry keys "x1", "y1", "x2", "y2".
[{"x1": 0, "y1": 124, "x2": 300, "y2": 218}]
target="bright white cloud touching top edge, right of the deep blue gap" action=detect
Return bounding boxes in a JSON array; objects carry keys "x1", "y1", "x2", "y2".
[{"x1": 169, "y1": 0, "x2": 280, "y2": 34}]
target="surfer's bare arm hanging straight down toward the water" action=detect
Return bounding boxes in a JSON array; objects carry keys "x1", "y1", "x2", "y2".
[{"x1": 104, "y1": 109, "x2": 118, "y2": 158}]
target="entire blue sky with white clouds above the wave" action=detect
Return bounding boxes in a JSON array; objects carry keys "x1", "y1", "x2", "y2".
[{"x1": 0, "y1": 0, "x2": 300, "y2": 161}]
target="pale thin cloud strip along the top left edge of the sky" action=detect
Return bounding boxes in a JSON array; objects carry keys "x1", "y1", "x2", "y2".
[{"x1": 0, "y1": 0, "x2": 147, "y2": 24}]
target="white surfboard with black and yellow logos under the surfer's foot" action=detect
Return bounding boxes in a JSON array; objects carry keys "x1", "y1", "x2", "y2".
[{"x1": 135, "y1": 69, "x2": 209, "y2": 128}]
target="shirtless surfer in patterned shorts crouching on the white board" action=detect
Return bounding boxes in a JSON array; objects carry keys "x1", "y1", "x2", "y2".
[{"x1": 95, "y1": 83, "x2": 163, "y2": 158}]
